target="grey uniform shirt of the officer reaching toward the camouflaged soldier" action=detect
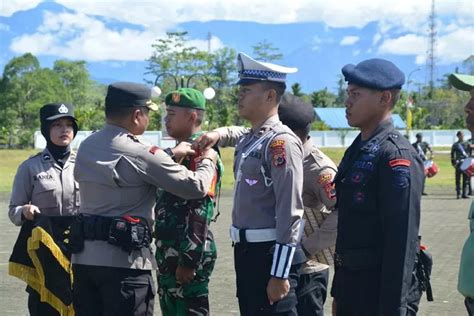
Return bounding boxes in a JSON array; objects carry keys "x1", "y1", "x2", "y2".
[{"x1": 72, "y1": 124, "x2": 214, "y2": 270}]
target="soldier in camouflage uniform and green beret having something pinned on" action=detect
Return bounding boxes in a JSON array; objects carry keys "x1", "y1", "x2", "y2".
[{"x1": 155, "y1": 88, "x2": 223, "y2": 315}]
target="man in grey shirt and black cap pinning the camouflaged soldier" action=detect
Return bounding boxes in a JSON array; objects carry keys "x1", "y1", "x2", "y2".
[{"x1": 71, "y1": 82, "x2": 216, "y2": 316}]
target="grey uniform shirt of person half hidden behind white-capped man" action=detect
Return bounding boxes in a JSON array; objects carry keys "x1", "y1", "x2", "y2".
[{"x1": 301, "y1": 138, "x2": 337, "y2": 274}]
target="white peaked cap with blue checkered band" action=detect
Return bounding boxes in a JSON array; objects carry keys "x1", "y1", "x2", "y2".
[{"x1": 237, "y1": 53, "x2": 298, "y2": 84}]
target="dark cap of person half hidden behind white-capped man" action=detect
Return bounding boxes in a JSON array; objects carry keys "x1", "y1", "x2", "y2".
[{"x1": 278, "y1": 94, "x2": 315, "y2": 131}]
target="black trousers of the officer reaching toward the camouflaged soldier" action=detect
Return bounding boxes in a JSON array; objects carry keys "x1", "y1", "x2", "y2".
[{"x1": 72, "y1": 264, "x2": 156, "y2": 316}]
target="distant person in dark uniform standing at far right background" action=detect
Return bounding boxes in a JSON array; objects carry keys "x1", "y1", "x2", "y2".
[{"x1": 451, "y1": 131, "x2": 469, "y2": 199}]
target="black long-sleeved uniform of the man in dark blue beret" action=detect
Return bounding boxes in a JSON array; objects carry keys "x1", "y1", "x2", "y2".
[{"x1": 334, "y1": 120, "x2": 424, "y2": 315}]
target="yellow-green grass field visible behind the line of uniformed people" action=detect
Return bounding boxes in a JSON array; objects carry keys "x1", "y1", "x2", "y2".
[{"x1": 0, "y1": 147, "x2": 454, "y2": 192}]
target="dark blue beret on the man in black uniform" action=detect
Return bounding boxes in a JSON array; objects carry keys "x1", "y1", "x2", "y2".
[{"x1": 342, "y1": 58, "x2": 405, "y2": 90}]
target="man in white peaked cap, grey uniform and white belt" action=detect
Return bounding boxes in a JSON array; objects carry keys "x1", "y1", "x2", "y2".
[{"x1": 196, "y1": 53, "x2": 306, "y2": 316}]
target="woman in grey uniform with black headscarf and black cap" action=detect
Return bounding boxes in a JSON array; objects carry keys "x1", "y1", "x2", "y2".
[{"x1": 8, "y1": 103, "x2": 79, "y2": 315}]
